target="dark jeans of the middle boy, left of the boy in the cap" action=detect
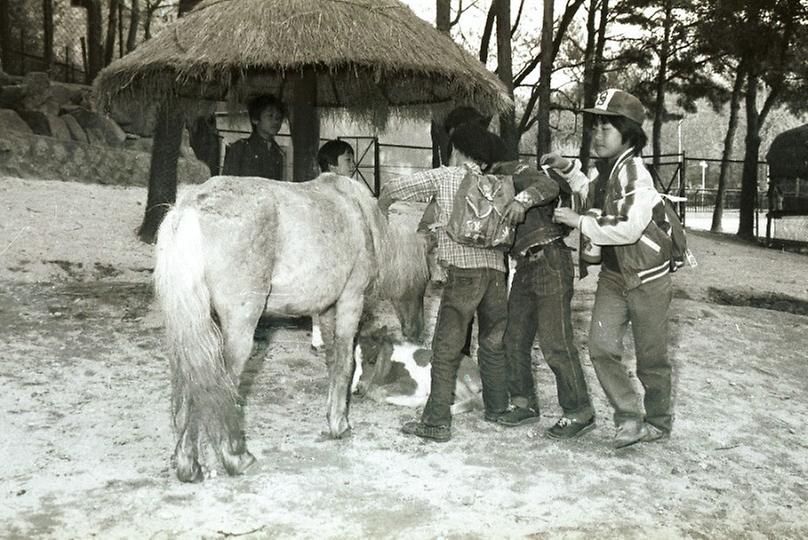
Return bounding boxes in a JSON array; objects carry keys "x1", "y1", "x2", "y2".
[{"x1": 505, "y1": 242, "x2": 595, "y2": 421}]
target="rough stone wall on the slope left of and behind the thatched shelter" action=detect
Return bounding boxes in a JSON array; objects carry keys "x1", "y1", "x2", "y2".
[{"x1": 0, "y1": 72, "x2": 210, "y2": 186}]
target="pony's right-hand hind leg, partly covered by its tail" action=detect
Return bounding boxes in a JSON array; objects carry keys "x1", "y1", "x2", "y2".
[{"x1": 211, "y1": 295, "x2": 265, "y2": 475}]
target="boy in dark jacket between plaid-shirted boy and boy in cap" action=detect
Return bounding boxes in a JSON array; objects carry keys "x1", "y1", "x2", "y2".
[{"x1": 491, "y1": 161, "x2": 595, "y2": 439}]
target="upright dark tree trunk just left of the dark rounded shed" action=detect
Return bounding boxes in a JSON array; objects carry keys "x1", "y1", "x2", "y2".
[{"x1": 738, "y1": 71, "x2": 760, "y2": 238}]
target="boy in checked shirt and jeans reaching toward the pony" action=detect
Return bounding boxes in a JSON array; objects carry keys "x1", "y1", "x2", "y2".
[{"x1": 379, "y1": 123, "x2": 536, "y2": 442}]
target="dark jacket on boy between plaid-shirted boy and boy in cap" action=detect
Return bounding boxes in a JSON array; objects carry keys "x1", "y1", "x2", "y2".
[{"x1": 490, "y1": 161, "x2": 571, "y2": 255}]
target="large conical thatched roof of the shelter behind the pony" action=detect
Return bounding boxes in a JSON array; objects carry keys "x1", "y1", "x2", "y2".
[{"x1": 96, "y1": 0, "x2": 512, "y2": 123}]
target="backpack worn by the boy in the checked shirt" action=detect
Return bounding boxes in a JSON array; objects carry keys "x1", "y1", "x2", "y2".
[{"x1": 446, "y1": 170, "x2": 516, "y2": 251}]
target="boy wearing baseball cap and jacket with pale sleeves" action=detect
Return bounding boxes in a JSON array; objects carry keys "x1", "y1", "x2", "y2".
[{"x1": 542, "y1": 89, "x2": 673, "y2": 448}]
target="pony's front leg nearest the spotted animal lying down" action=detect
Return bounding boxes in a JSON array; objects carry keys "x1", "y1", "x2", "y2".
[{"x1": 327, "y1": 300, "x2": 364, "y2": 439}]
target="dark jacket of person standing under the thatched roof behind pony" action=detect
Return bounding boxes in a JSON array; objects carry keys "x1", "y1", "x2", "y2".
[{"x1": 222, "y1": 132, "x2": 286, "y2": 180}]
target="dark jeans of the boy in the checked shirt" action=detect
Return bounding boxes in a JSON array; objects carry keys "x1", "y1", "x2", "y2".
[{"x1": 421, "y1": 266, "x2": 508, "y2": 426}]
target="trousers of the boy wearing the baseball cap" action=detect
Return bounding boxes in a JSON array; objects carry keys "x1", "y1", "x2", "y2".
[{"x1": 589, "y1": 269, "x2": 673, "y2": 432}]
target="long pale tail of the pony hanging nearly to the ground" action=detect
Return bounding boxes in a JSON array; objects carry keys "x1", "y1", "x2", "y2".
[{"x1": 154, "y1": 207, "x2": 240, "y2": 454}]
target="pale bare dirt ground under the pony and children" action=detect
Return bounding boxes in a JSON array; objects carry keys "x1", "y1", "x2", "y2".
[{"x1": 0, "y1": 178, "x2": 808, "y2": 539}]
